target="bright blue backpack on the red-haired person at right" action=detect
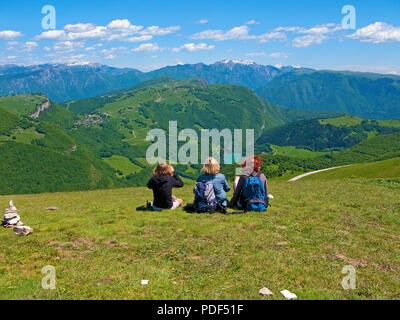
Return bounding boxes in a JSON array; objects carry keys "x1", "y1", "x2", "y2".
[{"x1": 241, "y1": 174, "x2": 269, "y2": 212}]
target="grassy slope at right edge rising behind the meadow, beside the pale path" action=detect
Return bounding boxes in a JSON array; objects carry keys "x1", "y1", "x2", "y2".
[{"x1": 304, "y1": 158, "x2": 400, "y2": 179}]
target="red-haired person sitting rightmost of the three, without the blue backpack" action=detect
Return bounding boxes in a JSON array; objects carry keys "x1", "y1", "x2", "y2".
[{"x1": 229, "y1": 156, "x2": 268, "y2": 209}]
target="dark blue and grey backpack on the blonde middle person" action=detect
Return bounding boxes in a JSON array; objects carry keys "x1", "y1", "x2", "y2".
[{"x1": 193, "y1": 182, "x2": 217, "y2": 213}]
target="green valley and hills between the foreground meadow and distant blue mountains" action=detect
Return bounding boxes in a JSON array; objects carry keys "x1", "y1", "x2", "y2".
[{"x1": 0, "y1": 77, "x2": 400, "y2": 194}]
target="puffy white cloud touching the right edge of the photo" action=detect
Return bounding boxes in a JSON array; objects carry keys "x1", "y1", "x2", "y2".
[{"x1": 348, "y1": 22, "x2": 400, "y2": 43}]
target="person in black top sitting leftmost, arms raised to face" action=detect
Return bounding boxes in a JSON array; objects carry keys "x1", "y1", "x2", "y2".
[{"x1": 147, "y1": 163, "x2": 183, "y2": 211}]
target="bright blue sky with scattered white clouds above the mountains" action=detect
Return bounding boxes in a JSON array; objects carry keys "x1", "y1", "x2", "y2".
[{"x1": 0, "y1": 0, "x2": 400, "y2": 74}]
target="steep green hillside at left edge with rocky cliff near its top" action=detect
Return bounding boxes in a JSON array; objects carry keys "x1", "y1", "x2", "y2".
[{"x1": 0, "y1": 95, "x2": 129, "y2": 194}]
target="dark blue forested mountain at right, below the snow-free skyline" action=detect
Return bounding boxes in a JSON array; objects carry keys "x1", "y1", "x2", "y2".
[{"x1": 257, "y1": 71, "x2": 400, "y2": 119}]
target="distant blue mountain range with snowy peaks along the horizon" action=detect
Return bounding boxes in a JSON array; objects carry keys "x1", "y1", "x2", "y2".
[{"x1": 0, "y1": 60, "x2": 400, "y2": 119}]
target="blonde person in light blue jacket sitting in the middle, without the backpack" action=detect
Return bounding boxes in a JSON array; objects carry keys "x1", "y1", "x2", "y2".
[{"x1": 197, "y1": 157, "x2": 231, "y2": 211}]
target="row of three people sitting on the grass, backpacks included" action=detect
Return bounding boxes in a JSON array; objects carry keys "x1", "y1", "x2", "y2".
[{"x1": 147, "y1": 156, "x2": 268, "y2": 213}]
